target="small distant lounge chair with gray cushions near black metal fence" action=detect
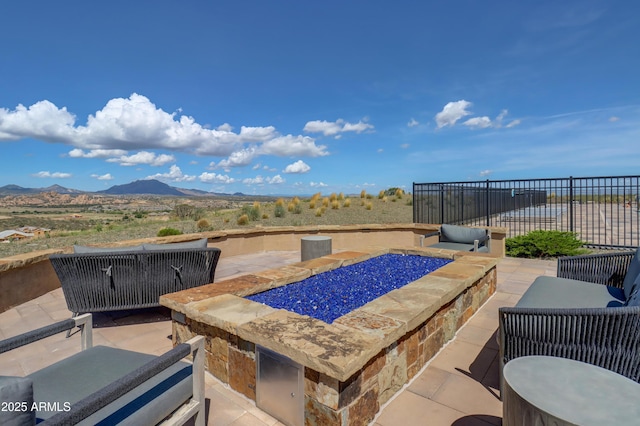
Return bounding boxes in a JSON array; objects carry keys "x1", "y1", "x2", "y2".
[{"x1": 420, "y1": 224, "x2": 491, "y2": 253}]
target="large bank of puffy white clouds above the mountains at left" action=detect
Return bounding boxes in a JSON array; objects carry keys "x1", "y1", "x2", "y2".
[{"x1": 0, "y1": 93, "x2": 330, "y2": 167}]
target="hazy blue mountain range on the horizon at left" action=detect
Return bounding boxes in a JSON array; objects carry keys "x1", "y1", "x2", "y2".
[{"x1": 0, "y1": 179, "x2": 244, "y2": 197}]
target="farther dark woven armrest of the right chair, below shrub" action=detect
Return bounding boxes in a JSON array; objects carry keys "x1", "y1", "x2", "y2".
[{"x1": 557, "y1": 252, "x2": 635, "y2": 288}]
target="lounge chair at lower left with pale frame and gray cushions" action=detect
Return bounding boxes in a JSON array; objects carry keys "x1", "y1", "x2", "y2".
[{"x1": 0, "y1": 314, "x2": 205, "y2": 425}]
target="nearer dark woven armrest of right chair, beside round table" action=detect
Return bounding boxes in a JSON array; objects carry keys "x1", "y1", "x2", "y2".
[{"x1": 499, "y1": 306, "x2": 640, "y2": 381}]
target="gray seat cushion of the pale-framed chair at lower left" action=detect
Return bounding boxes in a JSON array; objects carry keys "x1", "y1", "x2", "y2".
[{"x1": 28, "y1": 346, "x2": 193, "y2": 425}]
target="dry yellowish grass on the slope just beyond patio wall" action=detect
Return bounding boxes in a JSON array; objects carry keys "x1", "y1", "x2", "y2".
[{"x1": 0, "y1": 194, "x2": 413, "y2": 258}]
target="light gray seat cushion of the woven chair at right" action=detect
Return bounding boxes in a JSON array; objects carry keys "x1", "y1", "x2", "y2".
[{"x1": 516, "y1": 276, "x2": 626, "y2": 308}]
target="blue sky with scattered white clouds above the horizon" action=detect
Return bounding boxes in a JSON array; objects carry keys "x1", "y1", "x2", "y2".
[{"x1": 0, "y1": 0, "x2": 640, "y2": 194}]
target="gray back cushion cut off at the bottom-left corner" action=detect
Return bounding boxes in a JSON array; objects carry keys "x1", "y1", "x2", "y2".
[{"x1": 0, "y1": 376, "x2": 36, "y2": 425}]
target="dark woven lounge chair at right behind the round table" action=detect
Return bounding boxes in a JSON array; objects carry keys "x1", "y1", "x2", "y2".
[{"x1": 499, "y1": 250, "x2": 640, "y2": 381}]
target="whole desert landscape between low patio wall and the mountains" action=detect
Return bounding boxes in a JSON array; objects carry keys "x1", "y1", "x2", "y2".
[{"x1": 0, "y1": 188, "x2": 413, "y2": 258}]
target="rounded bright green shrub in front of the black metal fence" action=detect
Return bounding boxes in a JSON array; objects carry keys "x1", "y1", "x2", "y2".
[{"x1": 505, "y1": 230, "x2": 588, "y2": 259}]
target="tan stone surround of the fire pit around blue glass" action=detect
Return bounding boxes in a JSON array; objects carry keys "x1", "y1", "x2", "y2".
[{"x1": 161, "y1": 248, "x2": 497, "y2": 425}]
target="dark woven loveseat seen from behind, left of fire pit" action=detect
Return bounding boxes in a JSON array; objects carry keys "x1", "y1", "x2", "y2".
[{"x1": 49, "y1": 238, "x2": 221, "y2": 314}]
